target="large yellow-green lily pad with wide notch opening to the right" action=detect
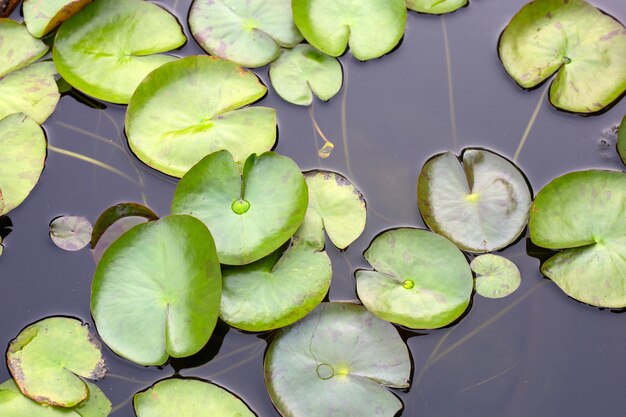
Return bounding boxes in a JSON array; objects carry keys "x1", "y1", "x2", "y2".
[{"x1": 126, "y1": 56, "x2": 276, "y2": 177}]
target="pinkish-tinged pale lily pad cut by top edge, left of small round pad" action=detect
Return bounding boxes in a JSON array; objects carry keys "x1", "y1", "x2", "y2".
[{"x1": 189, "y1": 0, "x2": 302, "y2": 67}]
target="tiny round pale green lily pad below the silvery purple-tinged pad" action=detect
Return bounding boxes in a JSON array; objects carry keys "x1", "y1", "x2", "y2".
[{"x1": 470, "y1": 254, "x2": 522, "y2": 298}]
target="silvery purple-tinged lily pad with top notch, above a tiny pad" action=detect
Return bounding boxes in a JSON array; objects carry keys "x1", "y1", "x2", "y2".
[{"x1": 417, "y1": 149, "x2": 532, "y2": 253}]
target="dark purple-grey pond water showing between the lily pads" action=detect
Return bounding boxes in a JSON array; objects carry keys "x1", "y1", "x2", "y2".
[{"x1": 0, "y1": 0, "x2": 626, "y2": 417}]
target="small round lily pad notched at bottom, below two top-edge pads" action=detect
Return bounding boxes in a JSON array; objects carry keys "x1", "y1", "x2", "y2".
[{"x1": 270, "y1": 44, "x2": 343, "y2": 106}]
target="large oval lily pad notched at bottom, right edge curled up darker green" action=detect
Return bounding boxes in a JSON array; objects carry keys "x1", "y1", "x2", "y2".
[{"x1": 91, "y1": 216, "x2": 222, "y2": 365}]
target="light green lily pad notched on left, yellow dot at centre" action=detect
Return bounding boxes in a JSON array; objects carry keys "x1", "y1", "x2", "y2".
[{"x1": 356, "y1": 228, "x2": 474, "y2": 329}]
